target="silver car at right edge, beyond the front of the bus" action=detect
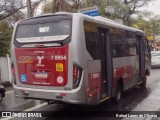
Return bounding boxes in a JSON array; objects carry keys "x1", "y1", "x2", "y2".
[{"x1": 151, "y1": 51, "x2": 160, "y2": 67}]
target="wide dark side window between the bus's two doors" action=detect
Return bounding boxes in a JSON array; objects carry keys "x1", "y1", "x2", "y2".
[{"x1": 110, "y1": 28, "x2": 137, "y2": 57}]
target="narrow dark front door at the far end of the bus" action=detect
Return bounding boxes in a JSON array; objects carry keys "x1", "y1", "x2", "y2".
[{"x1": 137, "y1": 35, "x2": 145, "y2": 82}]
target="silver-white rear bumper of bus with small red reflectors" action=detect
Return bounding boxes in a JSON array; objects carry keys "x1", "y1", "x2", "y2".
[{"x1": 13, "y1": 84, "x2": 87, "y2": 104}]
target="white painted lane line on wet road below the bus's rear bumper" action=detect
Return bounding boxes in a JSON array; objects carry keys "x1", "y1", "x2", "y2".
[{"x1": 0, "y1": 102, "x2": 48, "y2": 120}]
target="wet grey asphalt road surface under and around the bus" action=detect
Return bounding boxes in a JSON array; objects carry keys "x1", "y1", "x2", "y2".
[{"x1": 0, "y1": 69, "x2": 160, "y2": 120}]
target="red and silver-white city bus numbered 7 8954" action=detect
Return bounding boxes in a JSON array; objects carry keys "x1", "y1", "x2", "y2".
[{"x1": 11, "y1": 13, "x2": 151, "y2": 104}]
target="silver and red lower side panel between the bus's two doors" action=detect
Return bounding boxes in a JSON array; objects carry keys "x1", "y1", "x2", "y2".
[{"x1": 112, "y1": 56, "x2": 138, "y2": 94}]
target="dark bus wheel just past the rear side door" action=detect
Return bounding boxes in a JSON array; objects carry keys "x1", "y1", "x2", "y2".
[{"x1": 113, "y1": 83, "x2": 122, "y2": 103}]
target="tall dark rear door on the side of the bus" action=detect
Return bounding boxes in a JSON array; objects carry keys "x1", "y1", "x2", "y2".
[{"x1": 98, "y1": 28, "x2": 112, "y2": 99}]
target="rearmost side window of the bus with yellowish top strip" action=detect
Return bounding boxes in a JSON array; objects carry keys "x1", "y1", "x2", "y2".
[{"x1": 84, "y1": 21, "x2": 100, "y2": 60}]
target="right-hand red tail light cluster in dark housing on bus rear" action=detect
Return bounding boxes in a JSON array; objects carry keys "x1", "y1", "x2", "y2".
[{"x1": 73, "y1": 65, "x2": 82, "y2": 88}]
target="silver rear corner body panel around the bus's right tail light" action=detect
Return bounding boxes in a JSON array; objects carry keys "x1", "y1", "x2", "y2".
[{"x1": 67, "y1": 14, "x2": 91, "y2": 104}]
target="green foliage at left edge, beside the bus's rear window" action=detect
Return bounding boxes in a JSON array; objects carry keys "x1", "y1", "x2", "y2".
[{"x1": 0, "y1": 21, "x2": 12, "y2": 57}]
